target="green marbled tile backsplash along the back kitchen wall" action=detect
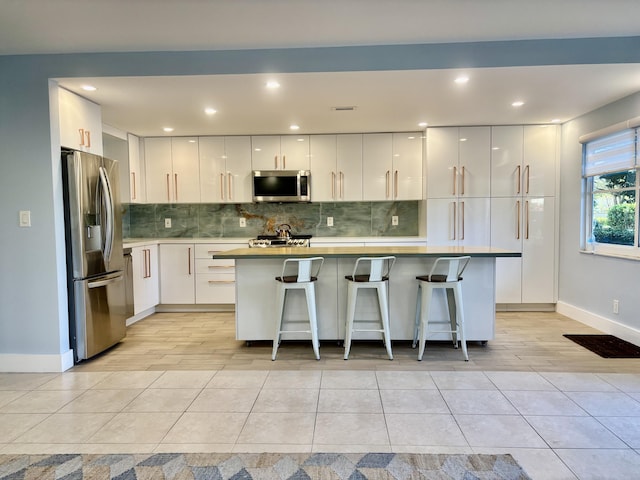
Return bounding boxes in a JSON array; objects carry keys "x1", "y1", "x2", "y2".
[{"x1": 122, "y1": 201, "x2": 419, "y2": 238}]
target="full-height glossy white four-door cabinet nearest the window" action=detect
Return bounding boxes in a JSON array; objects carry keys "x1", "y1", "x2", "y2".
[{"x1": 491, "y1": 125, "x2": 560, "y2": 304}]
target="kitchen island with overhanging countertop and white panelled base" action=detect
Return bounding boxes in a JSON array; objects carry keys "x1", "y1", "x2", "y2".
[{"x1": 215, "y1": 246, "x2": 521, "y2": 342}]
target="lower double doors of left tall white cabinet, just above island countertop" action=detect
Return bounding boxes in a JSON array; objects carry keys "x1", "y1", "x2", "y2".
[{"x1": 427, "y1": 198, "x2": 491, "y2": 246}]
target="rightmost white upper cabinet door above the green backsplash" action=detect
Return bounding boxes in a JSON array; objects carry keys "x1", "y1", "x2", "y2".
[{"x1": 392, "y1": 132, "x2": 422, "y2": 200}]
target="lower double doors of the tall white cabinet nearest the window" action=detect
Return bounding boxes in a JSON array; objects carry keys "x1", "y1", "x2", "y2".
[{"x1": 491, "y1": 197, "x2": 557, "y2": 303}]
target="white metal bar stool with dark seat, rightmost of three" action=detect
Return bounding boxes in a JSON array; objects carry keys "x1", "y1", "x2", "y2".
[{"x1": 413, "y1": 256, "x2": 471, "y2": 362}]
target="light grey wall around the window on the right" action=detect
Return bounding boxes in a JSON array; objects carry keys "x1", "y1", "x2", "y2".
[{"x1": 558, "y1": 93, "x2": 640, "y2": 330}]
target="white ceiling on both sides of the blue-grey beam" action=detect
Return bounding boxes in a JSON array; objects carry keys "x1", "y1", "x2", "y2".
[{"x1": 0, "y1": 0, "x2": 640, "y2": 136}]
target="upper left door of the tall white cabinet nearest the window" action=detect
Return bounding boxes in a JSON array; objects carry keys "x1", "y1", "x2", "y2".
[{"x1": 491, "y1": 126, "x2": 523, "y2": 197}]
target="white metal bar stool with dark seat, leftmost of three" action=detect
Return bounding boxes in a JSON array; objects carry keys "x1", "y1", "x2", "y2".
[{"x1": 271, "y1": 257, "x2": 324, "y2": 360}]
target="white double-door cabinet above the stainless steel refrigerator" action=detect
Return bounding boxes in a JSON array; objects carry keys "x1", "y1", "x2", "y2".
[{"x1": 58, "y1": 88, "x2": 103, "y2": 155}]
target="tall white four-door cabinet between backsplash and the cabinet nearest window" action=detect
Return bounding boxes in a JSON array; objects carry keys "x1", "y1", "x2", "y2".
[{"x1": 427, "y1": 127, "x2": 491, "y2": 246}]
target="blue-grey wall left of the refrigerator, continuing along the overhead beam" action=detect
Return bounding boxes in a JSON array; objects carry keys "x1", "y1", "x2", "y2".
[{"x1": 0, "y1": 37, "x2": 640, "y2": 369}]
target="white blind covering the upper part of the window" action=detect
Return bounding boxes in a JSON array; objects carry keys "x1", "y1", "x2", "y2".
[{"x1": 583, "y1": 129, "x2": 636, "y2": 177}]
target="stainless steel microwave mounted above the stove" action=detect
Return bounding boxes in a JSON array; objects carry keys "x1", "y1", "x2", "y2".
[{"x1": 253, "y1": 170, "x2": 311, "y2": 202}]
